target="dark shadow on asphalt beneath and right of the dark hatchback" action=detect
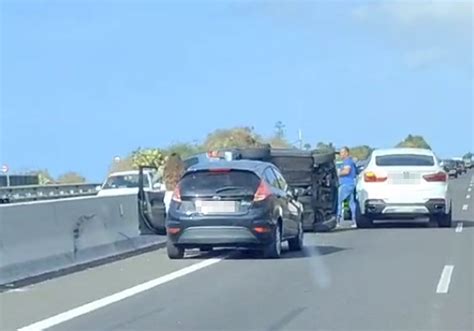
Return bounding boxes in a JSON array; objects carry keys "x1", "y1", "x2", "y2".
[{"x1": 185, "y1": 245, "x2": 348, "y2": 261}]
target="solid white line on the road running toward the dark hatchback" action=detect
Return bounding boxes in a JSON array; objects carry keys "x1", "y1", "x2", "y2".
[{"x1": 18, "y1": 257, "x2": 225, "y2": 331}]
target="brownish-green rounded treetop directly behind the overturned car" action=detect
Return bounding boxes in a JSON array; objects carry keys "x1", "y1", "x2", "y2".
[{"x1": 203, "y1": 127, "x2": 263, "y2": 150}]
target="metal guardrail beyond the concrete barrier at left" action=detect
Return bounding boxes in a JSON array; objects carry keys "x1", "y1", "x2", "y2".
[{"x1": 0, "y1": 183, "x2": 101, "y2": 203}]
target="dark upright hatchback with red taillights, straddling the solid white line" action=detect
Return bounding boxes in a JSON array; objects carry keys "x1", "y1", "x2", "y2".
[{"x1": 166, "y1": 160, "x2": 303, "y2": 259}]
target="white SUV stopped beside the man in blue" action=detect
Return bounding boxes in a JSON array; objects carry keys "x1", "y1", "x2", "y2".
[{"x1": 356, "y1": 148, "x2": 452, "y2": 228}]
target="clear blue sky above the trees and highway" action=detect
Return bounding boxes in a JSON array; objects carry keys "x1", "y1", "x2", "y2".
[{"x1": 0, "y1": 0, "x2": 474, "y2": 180}]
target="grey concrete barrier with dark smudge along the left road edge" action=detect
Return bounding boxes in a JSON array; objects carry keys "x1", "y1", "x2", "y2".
[{"x1": 0, "y1": 195, "x2": 163, "y2": 284}]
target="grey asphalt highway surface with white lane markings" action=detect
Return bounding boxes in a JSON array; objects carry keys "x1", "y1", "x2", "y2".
[{"x1": 0, "y1": 171, "x2": 474, "y2": 331}]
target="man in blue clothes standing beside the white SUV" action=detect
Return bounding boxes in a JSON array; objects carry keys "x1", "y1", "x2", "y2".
[{"x1": 337, "y1": 147, "x2": 357, "y2": 227}]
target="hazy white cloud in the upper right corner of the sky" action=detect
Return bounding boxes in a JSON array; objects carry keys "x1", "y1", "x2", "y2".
[{"x1": 352, "y1": 0, "x2": 474, "y2": 68}]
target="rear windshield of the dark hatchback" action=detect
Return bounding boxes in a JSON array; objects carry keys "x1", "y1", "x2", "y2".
[{"x1": 179, "y1": 170, "x2": 260, "y2": 196}]
